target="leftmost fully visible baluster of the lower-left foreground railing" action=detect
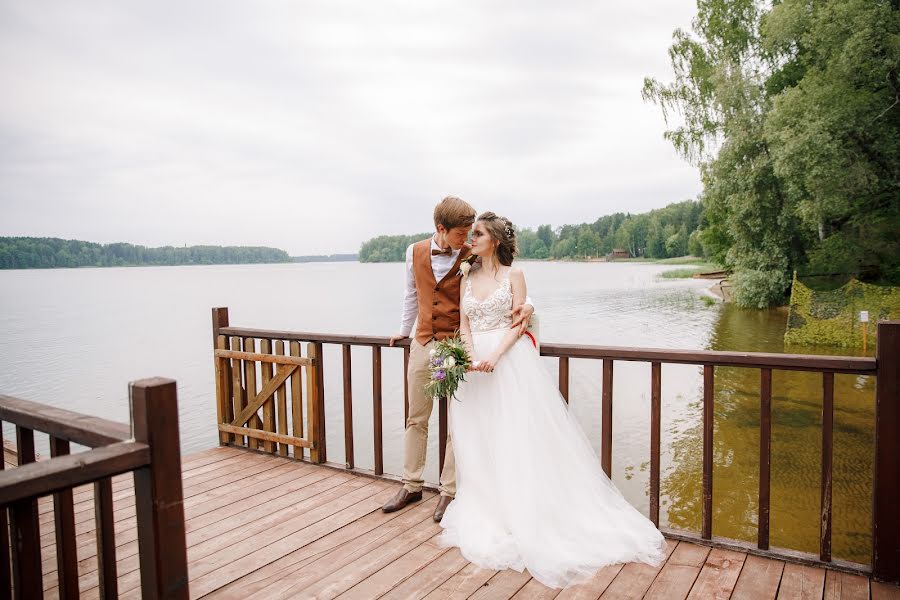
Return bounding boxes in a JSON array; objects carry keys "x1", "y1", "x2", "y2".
[{"x1": 9, "y1": 425, "x2": 43, "y2": 598}]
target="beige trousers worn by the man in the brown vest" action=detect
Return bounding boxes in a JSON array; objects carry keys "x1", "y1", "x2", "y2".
[{"x1": 403, "y1": 338, "x2": 456, "y2": 498}]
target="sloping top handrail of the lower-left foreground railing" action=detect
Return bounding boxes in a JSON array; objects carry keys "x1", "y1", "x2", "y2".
[{"x1": 0, "y1": 394, "x2": 131, "y2": 448}]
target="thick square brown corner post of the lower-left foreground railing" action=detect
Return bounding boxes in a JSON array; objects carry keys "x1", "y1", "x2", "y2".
[{"x1": 129, "y1": 378, "x2": 188, "y2": 599}]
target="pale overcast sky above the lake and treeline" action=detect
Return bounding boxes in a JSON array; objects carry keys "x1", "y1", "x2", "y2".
[{"x1": 0, "y1": 0, "x2": 700, "y2": 255}]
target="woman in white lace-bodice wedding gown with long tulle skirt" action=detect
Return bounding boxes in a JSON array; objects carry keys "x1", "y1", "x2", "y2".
[{"x1": 439, "y1": 212, "x2": 665, "y2": 588}]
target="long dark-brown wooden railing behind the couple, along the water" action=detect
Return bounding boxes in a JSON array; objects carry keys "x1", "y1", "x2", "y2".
[{"x1": 213, "y1": 308, "x2": 900, "y2": 583}]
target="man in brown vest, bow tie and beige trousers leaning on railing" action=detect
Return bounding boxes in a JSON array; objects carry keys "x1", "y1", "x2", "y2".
[{"x1": 382, "y1": 196, "x2": 534, "y2": 521}]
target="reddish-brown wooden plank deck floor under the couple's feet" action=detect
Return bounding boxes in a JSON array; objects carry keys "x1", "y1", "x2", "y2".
[{"x1": 26, "y1": 448, "x2": 900, "y2": 600}]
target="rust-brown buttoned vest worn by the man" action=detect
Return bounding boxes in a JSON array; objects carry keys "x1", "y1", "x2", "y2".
[{"x1": 413, "y1": 239, "x2": 470, "y2": 346}]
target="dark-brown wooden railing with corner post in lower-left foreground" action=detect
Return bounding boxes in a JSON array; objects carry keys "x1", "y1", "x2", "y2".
[{"x1": 0, "y1": 379, "x2": 188, "y2": 599}]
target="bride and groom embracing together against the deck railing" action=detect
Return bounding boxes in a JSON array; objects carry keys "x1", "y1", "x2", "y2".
[{"x1": 383, "y1": 197, "x2": 665, "y2": 588}]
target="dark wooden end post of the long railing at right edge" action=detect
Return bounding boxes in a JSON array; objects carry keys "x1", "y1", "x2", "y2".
[{"x1": 872, "y1": 321, "x2": 900, "y2": 583}]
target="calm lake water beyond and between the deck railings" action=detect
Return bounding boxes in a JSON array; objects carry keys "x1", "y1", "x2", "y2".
[{"x1": 0, "y1": 262, "x2": 874, "y2": 563}]
